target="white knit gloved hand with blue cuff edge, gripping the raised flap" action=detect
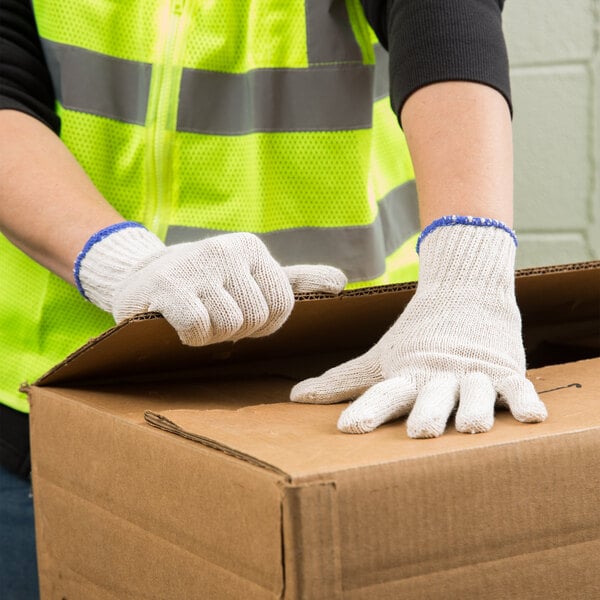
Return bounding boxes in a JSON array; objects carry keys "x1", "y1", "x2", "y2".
[{"x1": 74, "y1": 222, "x2": 346, "y2": 346}]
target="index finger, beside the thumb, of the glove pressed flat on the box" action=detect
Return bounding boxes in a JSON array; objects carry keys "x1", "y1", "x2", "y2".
[{"x1": 337, "y1": 377, "x2": 417, "y2": 433}]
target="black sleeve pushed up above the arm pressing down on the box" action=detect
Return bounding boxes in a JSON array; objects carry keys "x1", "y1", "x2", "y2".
[{"x1": 361, "y1": 0, "x2": 512, "y2": 123}]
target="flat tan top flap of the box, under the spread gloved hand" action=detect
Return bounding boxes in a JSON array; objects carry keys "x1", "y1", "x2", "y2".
[{"x1": 146, "y1": 358, "x2": 600, "y2": 483}]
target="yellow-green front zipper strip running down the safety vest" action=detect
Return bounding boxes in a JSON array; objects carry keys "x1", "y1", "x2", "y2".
[{"x1": 144, "y1": 0, "x2": 186, "y2": 240}]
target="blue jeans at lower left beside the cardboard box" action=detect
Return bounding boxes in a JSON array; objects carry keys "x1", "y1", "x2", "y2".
[{"x1": 0, "y1": 466, "x2": 40, "y2": 600}]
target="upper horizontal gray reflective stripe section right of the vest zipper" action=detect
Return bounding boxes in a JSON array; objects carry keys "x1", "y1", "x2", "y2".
[{"x1": 177, "y1": 65, "x2": 374, "y2": 135}]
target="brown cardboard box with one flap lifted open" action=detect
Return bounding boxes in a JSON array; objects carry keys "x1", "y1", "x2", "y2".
[{"x1": 28, "y1": 263, "x2": 600, "y2": 600}]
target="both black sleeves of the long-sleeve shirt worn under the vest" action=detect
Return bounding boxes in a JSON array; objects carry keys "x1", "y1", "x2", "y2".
[{"x1": 0, "y1": 0, "x2": 510, "y2": 133}]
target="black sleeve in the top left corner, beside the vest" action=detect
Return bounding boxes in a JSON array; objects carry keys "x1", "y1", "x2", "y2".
[{"x1": 0, "y1": 0, "x2": 60, "y2": 133}]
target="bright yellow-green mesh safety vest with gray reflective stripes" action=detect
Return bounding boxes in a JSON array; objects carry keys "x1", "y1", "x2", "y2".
[{"x1": 0, "y1": 0, "x2": 418, "y2": 411}]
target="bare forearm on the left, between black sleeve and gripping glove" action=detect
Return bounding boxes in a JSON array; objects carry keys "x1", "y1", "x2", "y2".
[{"x1": 0, "y1": 110, "x2": 123, "y2": 283}]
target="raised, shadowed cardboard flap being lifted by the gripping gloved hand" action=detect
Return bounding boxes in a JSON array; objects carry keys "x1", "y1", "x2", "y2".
[{"x1": 35, "y1": 261, "x2": 600, "y2": 386}]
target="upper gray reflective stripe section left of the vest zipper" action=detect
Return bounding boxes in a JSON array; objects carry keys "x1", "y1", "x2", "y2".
[{"x1": 42, "y1": 40, "x2": 152, "y2": 125}]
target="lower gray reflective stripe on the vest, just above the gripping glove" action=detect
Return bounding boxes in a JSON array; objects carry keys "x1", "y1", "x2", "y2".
[{"x1": 167, "y1": 181, "x2": 419, "y2": 281}]
